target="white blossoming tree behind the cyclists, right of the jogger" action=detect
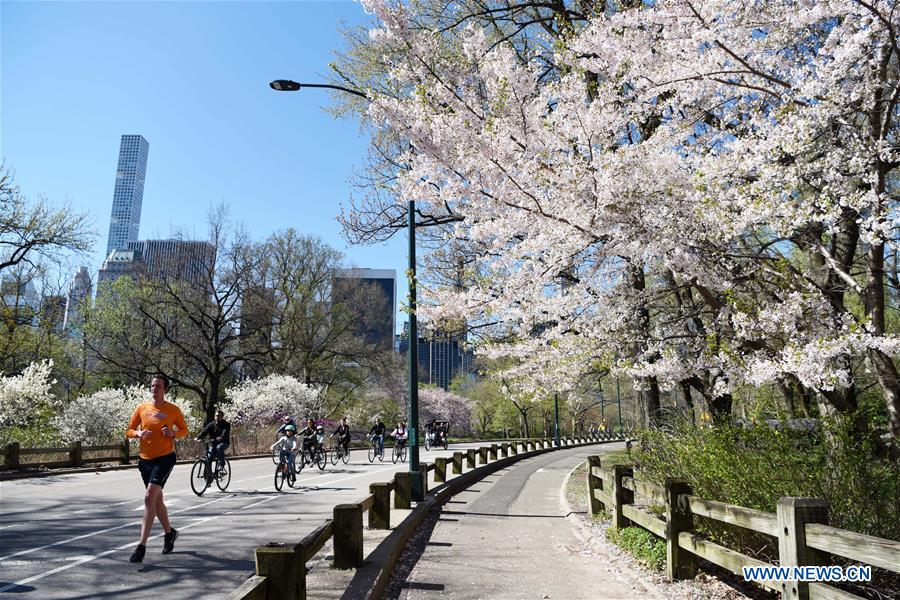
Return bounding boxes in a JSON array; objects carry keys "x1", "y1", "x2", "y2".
[{"x1": 225, "y1": 374, "x2": 325, "y2": 427}]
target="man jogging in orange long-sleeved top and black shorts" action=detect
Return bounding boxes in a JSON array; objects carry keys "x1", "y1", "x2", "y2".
[{"x1": 125, "y1": 375, "x2": 188, "y2": 562}]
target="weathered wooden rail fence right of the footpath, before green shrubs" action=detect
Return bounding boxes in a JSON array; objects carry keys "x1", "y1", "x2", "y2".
[{"x1": 586, "y1": 456, "x2": 900, "y2": 600}]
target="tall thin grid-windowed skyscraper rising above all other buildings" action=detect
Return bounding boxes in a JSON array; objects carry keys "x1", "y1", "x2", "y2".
[{"x1": 106, "y1": 135, "x2": 150, "y2": 256}]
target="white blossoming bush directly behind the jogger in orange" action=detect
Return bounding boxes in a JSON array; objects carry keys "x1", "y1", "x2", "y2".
[{"x1": 54, "y1": 385, "x2": 201, "y2": 445}]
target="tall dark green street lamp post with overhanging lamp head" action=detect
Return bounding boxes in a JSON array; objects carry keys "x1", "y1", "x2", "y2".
[{"x1": 269, "y1": 79, "x2": 425, "y2": 502}]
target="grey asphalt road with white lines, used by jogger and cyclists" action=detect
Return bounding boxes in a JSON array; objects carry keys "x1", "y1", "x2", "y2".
[{"x1": 0, "y1": 444, "x2": 478, "y2": 600}]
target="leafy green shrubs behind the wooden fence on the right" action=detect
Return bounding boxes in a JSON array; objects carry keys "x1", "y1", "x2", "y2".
[{"x1": 633, "y1": 415, "x2": 900, "y2": 559}]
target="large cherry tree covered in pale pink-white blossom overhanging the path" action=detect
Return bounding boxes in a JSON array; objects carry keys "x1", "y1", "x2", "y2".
[{"x1": 350, "y1": 0, "x2": 900, "y2": 438}]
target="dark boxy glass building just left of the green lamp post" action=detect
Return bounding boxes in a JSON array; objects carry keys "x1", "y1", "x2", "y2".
[{"x1": 331, "y1": 269, "x2": 397, "y2": 348}]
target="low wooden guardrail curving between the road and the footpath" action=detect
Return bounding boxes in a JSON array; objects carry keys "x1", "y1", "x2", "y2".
[{"x1": 226, "y1": 434, "x2": 624, "y2": 600}]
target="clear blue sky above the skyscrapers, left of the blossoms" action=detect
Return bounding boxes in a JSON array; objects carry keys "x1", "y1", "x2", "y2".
[{"x1": 0, "y1": 0, "x2": 407, "y2": 326}]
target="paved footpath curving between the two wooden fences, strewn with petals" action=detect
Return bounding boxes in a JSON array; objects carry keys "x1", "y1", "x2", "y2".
[{"x1": 393, "y1": 444, "x2": 658, "y2": 600}]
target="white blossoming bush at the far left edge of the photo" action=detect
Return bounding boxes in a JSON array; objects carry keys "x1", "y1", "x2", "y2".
[{"x1": 0, "y1": 360, "x2": 57, "y2": 444}]
